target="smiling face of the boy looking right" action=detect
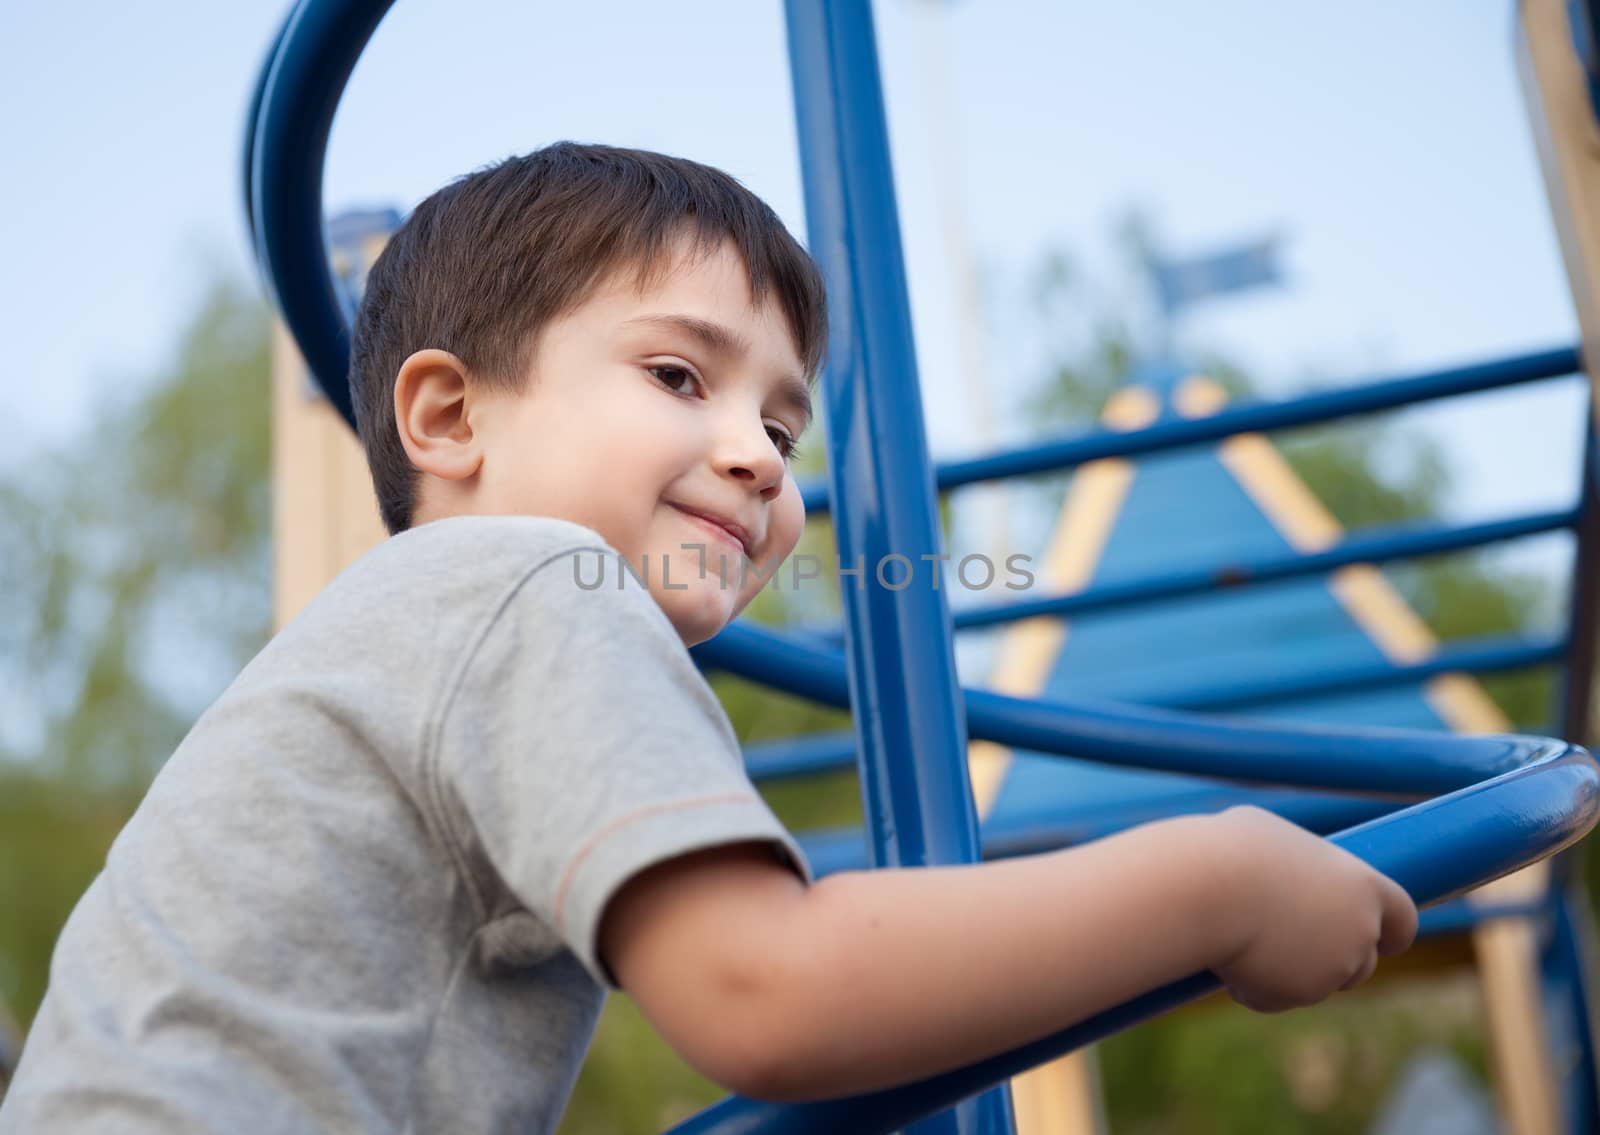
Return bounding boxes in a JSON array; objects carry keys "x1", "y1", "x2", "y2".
[{"x1": 474, "y1": 245, "x2": 808, "y2": 645}]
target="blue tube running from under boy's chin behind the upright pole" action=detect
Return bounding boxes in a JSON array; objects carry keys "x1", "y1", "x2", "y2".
[{"x1": 694, "y1": 623, "x2": 1563, "y2": 799}]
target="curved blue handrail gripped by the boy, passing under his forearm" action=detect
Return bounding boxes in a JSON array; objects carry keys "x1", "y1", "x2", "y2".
[{"x1": 674, "y1": 743, "x2": 1600, "y2": 1135}]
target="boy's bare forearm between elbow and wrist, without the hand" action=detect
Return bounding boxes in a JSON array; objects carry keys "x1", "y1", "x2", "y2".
[{"x1": 728, "y1": 818, "x2": 1243, "y2": 1098}]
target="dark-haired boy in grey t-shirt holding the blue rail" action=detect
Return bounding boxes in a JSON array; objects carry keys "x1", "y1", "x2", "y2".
[{"x1": 0, "y1": 144, "x2": 1416, "y2": 1135}]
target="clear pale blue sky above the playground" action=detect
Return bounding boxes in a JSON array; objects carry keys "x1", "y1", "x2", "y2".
[{"x1": 0, "y1": 0, "x2": 1581, "y2": 563}]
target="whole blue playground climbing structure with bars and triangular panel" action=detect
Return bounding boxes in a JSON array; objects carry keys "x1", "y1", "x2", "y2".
[{"x1": 245, "y1": 0, "x2": 1600, "y2": 1135}]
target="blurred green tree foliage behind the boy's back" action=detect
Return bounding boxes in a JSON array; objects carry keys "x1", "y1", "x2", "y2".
[{"x1": 0, "y1": 273, "x2": 270, "y2": 1025}]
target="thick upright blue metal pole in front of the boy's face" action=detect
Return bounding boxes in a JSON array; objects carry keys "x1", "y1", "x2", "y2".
[{"x1": 787, "y1": 0, "x2": 1013, "y2": 1135}]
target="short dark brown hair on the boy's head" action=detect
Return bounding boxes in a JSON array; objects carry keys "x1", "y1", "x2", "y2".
[{"x1": 350, "y1": 142, "x2": 827, "y2": 533}]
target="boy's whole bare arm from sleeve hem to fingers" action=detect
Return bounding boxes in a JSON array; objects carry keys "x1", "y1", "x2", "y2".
[{"x1": 600, "y1": 808, "x2": 1416, "y2": 1100}]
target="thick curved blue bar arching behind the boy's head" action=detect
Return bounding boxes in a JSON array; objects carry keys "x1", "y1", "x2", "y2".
[{"x1": 246, "y1": 0, "x2": 394, "y2": 429}]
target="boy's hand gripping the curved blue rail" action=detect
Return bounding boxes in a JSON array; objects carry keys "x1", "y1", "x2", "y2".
[{"x1": 1211, "y1": 807, "x2": 1416, "y2": 1013}]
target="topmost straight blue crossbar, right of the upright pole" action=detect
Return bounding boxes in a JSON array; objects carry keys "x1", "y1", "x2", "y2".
[{"x1": 802, "y1": 340, "x2": 1581, "y2": 512}]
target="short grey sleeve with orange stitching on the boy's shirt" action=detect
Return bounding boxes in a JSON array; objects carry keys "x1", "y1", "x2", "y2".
[{"x1": 432, "y1": 544, "x2": 810, "y2": 986}]
